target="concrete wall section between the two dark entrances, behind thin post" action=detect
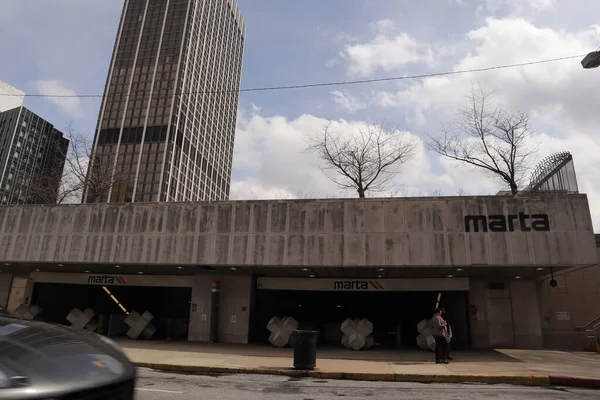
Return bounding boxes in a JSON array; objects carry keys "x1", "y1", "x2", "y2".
[{"x1": 188, "y1": 276, "x2": 252, "y2": 343}]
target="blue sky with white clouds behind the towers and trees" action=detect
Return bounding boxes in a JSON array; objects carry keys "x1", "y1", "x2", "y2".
[{"x1": 0, "y1": 0, "x2": 600, "y2": 231}]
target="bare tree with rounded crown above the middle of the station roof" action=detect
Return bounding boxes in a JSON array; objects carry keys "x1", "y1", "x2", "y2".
[{"x1": 308, "y1": 121, "x2": 417, "y2": 198}]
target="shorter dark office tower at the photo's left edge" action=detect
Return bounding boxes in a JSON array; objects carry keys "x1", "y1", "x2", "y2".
[{"x1": 0, "y1": 106, "x2": 69, "y2": 204}]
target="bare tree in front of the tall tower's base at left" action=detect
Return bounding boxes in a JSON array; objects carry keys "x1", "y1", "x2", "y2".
[{"x1": 30, "y1": 127, "x2": 130, "y2": 204}]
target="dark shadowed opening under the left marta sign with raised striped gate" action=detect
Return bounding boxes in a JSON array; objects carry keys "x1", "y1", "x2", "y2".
[{"x1": 32, "y1": 282, "x2": 192, "y2": 340}]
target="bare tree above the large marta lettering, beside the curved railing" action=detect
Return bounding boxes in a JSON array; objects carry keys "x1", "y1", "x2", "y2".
[{"x1": 428, "y1": 86, "x2": 537, "y2": 195}]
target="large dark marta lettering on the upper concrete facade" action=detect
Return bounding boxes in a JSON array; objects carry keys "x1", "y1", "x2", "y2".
[{"x1": 465, "y1": 212, "x2": 550, "y2": 232}]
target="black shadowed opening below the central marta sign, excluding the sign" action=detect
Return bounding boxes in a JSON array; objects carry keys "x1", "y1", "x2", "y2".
[{"x1": 250, "y1": 290, "x2": 470, "y2": 349}]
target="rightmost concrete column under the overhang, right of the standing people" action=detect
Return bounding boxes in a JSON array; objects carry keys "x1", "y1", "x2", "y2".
[{"x1": 510, "y1": 281, "x2": 543, "y2": 349}]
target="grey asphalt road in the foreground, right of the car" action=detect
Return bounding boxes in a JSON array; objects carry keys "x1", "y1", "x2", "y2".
[{"x1": 136, "y1": 369, "x2": 600, "y2": 400}]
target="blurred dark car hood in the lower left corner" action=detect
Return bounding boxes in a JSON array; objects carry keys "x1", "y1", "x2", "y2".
[{"x1": 0, "y1": 317, "x2": 135, "y2": 392}]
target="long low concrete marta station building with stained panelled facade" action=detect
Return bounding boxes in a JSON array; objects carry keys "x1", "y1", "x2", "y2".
[{"x1": 0, "y1": 194, "x2": 598, "y2": 348}]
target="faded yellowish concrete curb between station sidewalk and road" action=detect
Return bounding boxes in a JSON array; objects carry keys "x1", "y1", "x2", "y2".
[{"x1": 134, "y1": 362, "x2": 556, "y2": 388}]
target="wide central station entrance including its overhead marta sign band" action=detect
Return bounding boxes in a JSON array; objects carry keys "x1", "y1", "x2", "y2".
[{"x1": 251, "y1": 278, "x2": 470, "y2": 349}]
